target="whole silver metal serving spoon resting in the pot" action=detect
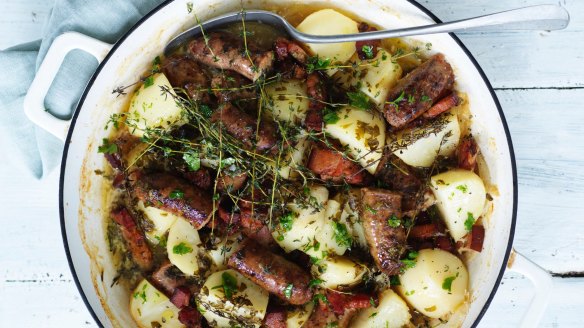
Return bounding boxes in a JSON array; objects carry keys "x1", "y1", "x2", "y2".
[{"x1": 164, "y1": 5, "x2": 570, "y2": 55}]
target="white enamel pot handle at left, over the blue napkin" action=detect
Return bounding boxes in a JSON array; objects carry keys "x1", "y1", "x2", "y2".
[{"x1": 24, "y1": 32, "x2": 112, "y2": 141}]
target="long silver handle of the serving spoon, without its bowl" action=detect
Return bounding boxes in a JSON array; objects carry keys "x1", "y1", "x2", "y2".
[{"x1": 290, "y1": 5, "x2": 570, "y2": 43}]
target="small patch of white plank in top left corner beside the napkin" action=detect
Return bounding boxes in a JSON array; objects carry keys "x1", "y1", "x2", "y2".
[{"x1": 0, "y1": 0, "x2": 54, "y2": 49}]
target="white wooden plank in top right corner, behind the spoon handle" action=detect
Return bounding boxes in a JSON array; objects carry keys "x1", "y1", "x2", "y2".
[{"x1": 421, "y1": 0, "x2": 584, "y2": 88}]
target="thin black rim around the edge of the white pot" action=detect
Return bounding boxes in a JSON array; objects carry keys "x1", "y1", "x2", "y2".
[{"x1": 59, "y1": 0, "x2": 518, "y2": 327}]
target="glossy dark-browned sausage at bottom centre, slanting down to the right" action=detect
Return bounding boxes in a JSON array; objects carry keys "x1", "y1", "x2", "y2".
[{"x1": 227, "y1": 240, "x2": 312, "y2": 305}]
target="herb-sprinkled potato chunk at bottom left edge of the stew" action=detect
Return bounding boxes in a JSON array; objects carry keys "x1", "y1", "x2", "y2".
[{"x1": 130, "y1": 279, "x2": 184, "y2": 328}]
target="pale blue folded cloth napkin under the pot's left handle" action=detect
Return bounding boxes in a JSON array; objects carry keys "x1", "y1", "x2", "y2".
[{"x1": 0, "y1": 0, "x2": 163, "y2": 178}]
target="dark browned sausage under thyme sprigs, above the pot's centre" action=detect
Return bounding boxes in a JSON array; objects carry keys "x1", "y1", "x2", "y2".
[{"x1": 211, "y1": 103, "x2": 276, "y2": 151}]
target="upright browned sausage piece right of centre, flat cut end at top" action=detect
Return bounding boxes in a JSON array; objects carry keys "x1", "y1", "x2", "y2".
[{"x1": 360, "y1": 188, "x2": 406, "y2": 276}]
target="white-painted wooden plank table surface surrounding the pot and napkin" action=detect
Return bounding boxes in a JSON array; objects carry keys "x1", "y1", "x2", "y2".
[{"x1": 0, "y1": 0, "x2": 584, "y2": 327}]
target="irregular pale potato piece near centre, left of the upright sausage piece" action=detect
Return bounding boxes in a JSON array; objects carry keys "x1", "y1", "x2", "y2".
[{"x1": 272, "y1": 186, "x2": 329, "y2": 252}]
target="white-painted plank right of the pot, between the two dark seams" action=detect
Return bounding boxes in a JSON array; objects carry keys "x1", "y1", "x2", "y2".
[{"x1": 497, "y1": 89, "x2": 584, "y2": 272}]
